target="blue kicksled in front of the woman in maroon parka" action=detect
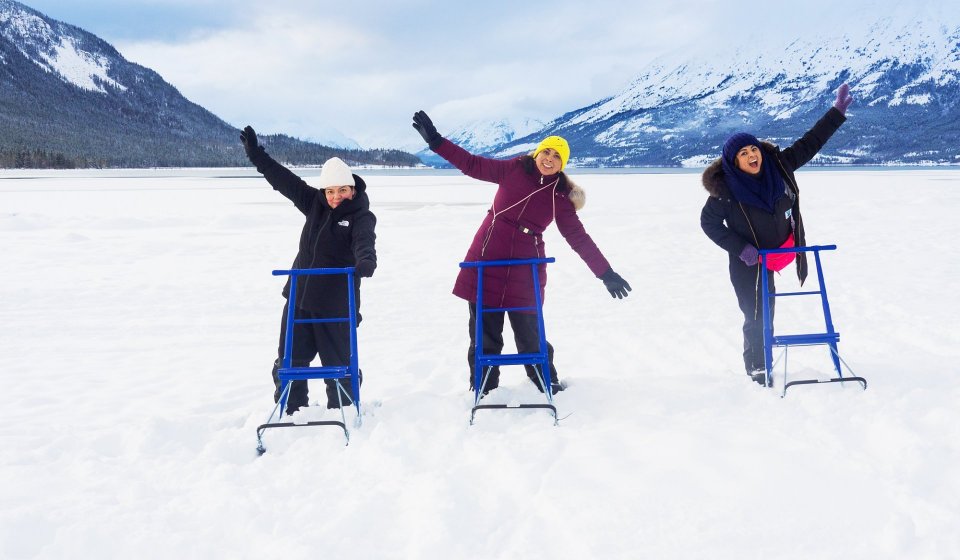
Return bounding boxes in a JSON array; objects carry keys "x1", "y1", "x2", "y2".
[{"x1": 460, "y1": 257, "x2": 558, "y2": 425}]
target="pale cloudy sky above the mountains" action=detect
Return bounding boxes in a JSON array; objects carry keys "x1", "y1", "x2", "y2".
[{"x1": 24, "y1": 0, "x2": 960, "y2": 147}]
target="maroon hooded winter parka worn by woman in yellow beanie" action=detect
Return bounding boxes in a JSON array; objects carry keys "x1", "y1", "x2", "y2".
[{"x1": 434, "y1": 139, "x2": 610, "y2": 307}]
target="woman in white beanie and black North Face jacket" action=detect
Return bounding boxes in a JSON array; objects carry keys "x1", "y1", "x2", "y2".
[{"x1": 240, "y1": 126, "x2": 377, "y2": 414}]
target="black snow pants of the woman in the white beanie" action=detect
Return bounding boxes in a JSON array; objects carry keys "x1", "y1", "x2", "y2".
[{"x1": 273, "y1": 302, "x2": 363, "y2": 414}]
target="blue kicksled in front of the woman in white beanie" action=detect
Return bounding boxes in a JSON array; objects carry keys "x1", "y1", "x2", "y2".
[{"x1": 257, "y1": 267, "x2": 361, "y2": 455}]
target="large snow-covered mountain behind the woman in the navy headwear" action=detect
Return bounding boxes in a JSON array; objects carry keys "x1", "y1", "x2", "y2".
[{"x1": 468, "y1": 14, "x2": 960, "y2": 166}]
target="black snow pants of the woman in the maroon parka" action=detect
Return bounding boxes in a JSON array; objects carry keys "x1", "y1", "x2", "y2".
[{"x1": 467, "y1": 303, "x2": 563, "y2": 394}]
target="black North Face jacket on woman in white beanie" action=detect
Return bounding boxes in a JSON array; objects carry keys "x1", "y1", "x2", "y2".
[{"x1": 252, "y1": 149, "x2": 377, "y2": 320}]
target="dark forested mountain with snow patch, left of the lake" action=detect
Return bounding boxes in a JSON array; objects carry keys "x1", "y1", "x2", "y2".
[{"x1": 0, "y1": 0, "x2": 417, "y2": 167}]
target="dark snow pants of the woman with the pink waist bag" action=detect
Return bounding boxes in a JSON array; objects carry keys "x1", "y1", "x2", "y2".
[{"x1": 730, "y1": 258, "x2": 776, "y2": 374}]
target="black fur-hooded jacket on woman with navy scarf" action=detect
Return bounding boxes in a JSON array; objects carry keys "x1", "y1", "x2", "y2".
[{"x1": 700, "y1": 108, "x2": 846, "y2": 284}]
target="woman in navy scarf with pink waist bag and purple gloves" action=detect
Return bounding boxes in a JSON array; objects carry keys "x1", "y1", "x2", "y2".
[{"x1": 700, "y1": 84, "x2": 853, "y2": 385}]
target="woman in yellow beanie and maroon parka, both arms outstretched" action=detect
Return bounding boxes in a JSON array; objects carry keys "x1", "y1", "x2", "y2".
[{"x1": 413, "y1": 111, "x2": 630, "y2": 394}]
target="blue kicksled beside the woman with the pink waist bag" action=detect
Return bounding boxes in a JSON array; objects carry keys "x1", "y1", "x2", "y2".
[{"x1": 759, "y1": 245, "x2": 867, "y2": 398}]
